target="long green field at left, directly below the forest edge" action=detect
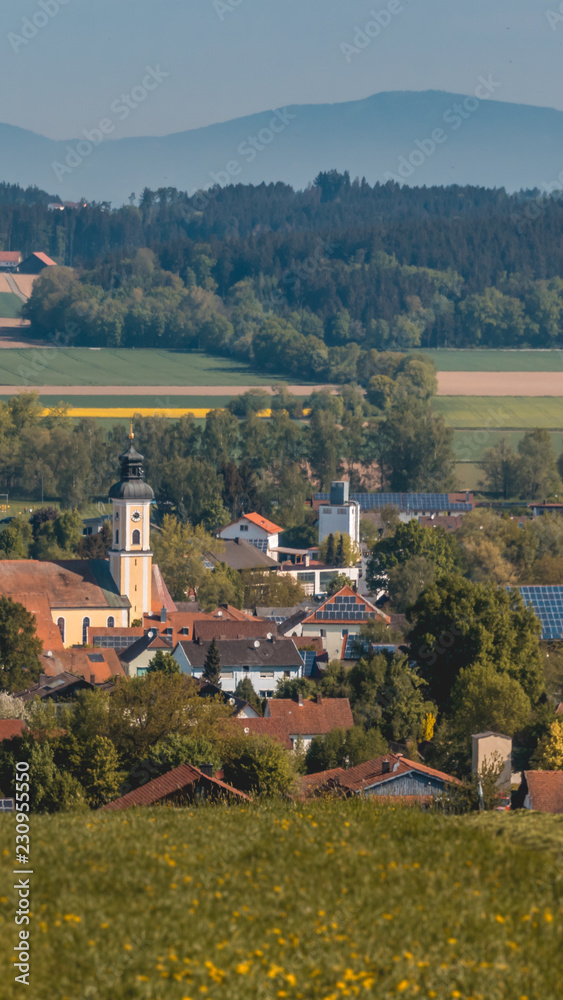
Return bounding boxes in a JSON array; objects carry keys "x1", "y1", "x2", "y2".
[{"x1": 0, "y1": 347, "x2": 300, "y2": 386}]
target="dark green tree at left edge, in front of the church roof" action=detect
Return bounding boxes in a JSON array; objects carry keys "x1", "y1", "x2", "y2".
[{"x1": 0, "y1": 596, "x2": 43, "y2": 691}]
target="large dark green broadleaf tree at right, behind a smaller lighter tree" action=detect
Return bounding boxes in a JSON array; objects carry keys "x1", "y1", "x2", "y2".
[{"x1": 408, "y1": 576, "x2": 544, "y2": 708}]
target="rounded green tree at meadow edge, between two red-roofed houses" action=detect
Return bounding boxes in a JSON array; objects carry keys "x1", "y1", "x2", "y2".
[{"x1": 222, "y1": 733, "x2": 295, "y2": 798}]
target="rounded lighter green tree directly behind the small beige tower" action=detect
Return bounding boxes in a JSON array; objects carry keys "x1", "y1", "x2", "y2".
[{"x1": 452, "y1": 663, "x2": 532, "y2": 736}]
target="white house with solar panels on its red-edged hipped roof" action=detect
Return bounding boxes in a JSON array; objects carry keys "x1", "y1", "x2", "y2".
[{"x1": 301, "y1": 587, "x2": 390, "y2": 660}]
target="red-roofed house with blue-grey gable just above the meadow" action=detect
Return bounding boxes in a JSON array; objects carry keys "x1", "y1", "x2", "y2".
[{"x1": 300, "y1": 753, "x2": 460, "y2": 802}]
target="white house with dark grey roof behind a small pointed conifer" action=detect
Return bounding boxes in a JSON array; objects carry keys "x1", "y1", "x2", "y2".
[{"x1": 174, "y1": 635, "x2": 303, "y2": 698}]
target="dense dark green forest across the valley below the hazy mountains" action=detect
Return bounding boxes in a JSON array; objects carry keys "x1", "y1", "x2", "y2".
[{"x1": 0, "y1": 171, "x2": 563, "y2": 383}]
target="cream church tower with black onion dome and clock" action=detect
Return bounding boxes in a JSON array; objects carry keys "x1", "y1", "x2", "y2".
[{"x1": 109, "y1": 425, "x2": 154, "y2": 621}]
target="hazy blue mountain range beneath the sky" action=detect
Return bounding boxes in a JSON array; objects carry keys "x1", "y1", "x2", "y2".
[{"x1": 0, "y1": 91, "x2": 563, "y2": 205}]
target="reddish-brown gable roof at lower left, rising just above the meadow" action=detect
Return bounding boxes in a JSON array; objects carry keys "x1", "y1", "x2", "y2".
[{"x1": 101, "y1": 764, "x2": 250, "y2": 810}]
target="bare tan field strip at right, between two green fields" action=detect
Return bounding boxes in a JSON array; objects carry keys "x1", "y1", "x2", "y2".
[{"x1": 438, "y1": 372, "x2": 563, "y2": 396}]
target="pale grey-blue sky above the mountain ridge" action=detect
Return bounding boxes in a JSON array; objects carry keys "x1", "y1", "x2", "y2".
[{"x1": 0, "y1": 0, "x2": 563, "y2": 139}]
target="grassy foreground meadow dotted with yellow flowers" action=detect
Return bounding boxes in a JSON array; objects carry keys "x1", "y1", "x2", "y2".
[{"x1": 0, "y1": 801, "x2": 563, "y2": 1000}]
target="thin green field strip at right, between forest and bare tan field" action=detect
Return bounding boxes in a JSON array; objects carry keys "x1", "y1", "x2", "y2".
[{"x1": 416, "y1": 348, "x2": 563, "y2": 372}]
